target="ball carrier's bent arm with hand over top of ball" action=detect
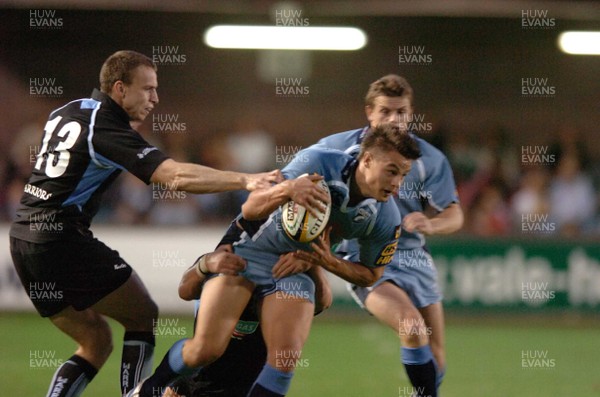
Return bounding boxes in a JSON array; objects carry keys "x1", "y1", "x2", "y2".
[{"x1": 242, "y1": 175, "x2": 330, "y2": 220}]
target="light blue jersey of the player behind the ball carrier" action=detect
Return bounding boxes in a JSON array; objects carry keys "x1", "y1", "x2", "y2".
[{"x1": 311, "y1": 127, "x2": 459, "y2": 249}]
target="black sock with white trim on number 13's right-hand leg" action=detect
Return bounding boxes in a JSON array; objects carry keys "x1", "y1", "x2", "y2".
[{"x1": 121, "y1": 331, "x2": 155, "y2": 394}]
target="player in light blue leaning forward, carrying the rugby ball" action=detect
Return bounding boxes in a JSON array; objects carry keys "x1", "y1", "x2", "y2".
[{"x1": 129, "y1": 125, "x2": 420, "y2": 397}]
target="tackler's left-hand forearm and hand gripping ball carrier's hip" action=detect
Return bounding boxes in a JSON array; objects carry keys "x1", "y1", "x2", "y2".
[{"x1": 178, "y1": 244, "x2": 246, "y2": 301}]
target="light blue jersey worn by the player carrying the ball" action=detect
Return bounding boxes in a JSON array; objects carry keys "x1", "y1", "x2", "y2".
[{"x1": 235, "y1": 148, "x2": 401, "y2": 267}]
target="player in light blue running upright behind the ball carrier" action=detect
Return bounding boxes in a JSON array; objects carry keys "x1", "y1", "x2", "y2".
[{"x1": 315, "y1": 75, "x2": 463, "y2": 396}]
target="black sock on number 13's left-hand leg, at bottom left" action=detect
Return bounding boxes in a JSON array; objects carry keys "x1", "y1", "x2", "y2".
[{"x1": 46, "y1": 355, "x2": 98, "y2": 397}]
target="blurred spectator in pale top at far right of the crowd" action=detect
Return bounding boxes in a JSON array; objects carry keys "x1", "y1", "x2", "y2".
[{"x1": 550, "y1": 150, "x2": 596, "y2": 237}]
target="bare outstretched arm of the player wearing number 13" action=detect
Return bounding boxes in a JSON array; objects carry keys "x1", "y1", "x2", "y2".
[{"x1": 150, "y1": 159, "x2": 283, "y2": 194}]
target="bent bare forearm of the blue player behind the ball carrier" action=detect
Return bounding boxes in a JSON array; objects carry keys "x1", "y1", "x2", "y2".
[{"x1": 402, "y1": 203, "x2": 464, "y2": 236}]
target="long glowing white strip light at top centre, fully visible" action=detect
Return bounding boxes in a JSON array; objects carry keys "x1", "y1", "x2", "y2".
[{"x1": 204, "y1": 25, "x2": 367, "y2": 51}]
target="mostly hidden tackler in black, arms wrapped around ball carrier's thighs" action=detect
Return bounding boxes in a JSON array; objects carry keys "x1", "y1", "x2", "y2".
[{"x1": 164, "y1": 217, "x2": 333, "y2": 397}]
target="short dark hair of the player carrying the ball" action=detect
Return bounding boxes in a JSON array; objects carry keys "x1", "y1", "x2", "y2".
[{"x1": 358, "y1": 124, "x2": 421, "y2": 160}]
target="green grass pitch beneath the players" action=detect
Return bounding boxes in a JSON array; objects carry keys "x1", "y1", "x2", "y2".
[{"x1": 0, "y1": 313, "x2": 600, "y2": 397}]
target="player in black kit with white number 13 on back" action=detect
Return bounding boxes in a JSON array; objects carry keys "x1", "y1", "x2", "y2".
[{"x1": 10, "y1": 51, "x2": 326, "y2": 397}]
